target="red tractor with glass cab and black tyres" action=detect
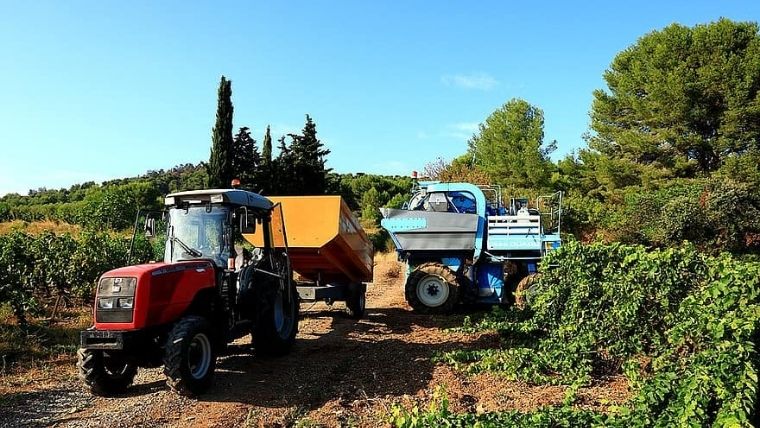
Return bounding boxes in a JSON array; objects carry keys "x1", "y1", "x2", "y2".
[{"x1": 77, "y1": 189, "x2": 299, "y2": 395}]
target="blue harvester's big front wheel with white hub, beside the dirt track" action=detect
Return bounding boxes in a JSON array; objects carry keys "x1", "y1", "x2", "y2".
[{"x1": 405, "y1": 263, "x2": 459, "y2": 314}]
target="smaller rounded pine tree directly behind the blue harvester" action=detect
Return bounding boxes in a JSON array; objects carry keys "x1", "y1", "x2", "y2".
[{"x1": 468, "y1": 99, "x2": 556, "y2": 189}]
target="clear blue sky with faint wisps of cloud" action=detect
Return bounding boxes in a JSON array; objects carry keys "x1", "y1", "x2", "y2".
[{"x1": 0, "y1": 0, "x2": 760, "y2": 194}]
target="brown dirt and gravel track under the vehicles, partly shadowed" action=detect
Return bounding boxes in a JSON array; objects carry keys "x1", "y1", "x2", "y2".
[{"x1": 0, "y1": 260, "x2": 627, "y2": 427}]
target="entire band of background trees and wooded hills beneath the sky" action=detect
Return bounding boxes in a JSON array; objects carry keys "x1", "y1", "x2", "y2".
[{"x1": 0, "y1": 19, "x2": 760, "y2": 253}]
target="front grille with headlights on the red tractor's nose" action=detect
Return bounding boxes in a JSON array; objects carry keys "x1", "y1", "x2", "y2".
[{"x1": 95, "y1": 278, "x2": 137, "y2": 322}]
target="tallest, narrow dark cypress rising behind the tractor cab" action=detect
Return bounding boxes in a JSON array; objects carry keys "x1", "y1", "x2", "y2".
[{"x1": 207, "y1": 76, "x2": 234, "y2": 188}]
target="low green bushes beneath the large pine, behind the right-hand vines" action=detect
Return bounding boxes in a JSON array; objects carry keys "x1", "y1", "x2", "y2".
[{"x1": 563, "y1": 178, "x2": 760, "y2": 254}]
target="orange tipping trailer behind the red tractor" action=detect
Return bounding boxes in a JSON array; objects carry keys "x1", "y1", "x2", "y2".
[{"x1": 244, "y1": 196, "x2": 373, "y2": 316}]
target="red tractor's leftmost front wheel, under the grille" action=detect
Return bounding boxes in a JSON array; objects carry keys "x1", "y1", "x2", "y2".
[{"x1": 77, "y1": 349, "x2": 137, "y2": 396}]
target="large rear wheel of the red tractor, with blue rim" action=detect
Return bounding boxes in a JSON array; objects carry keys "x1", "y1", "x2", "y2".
[{"x1": 253, "y1": 281, "x2": 299, "y2": 357}]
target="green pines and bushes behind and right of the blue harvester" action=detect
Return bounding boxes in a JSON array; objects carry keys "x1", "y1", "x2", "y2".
[{"x1": 434, "y1": 19, "x2": 760, "y2": 253}]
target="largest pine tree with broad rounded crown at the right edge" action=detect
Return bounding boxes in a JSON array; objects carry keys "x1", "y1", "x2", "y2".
[{"x1": 590, "y1": 19, "x2": 760, "y2": 177}]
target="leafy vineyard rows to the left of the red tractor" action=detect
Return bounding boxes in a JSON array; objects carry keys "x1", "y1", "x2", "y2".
[{"x1": 0, "y1": 231, "x2": 156, "y2": 324}]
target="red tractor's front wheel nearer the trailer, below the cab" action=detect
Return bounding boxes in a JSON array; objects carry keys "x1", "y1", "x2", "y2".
[{"x1": 164, "y1": 316, "x2": 216, "y2": 395}]
